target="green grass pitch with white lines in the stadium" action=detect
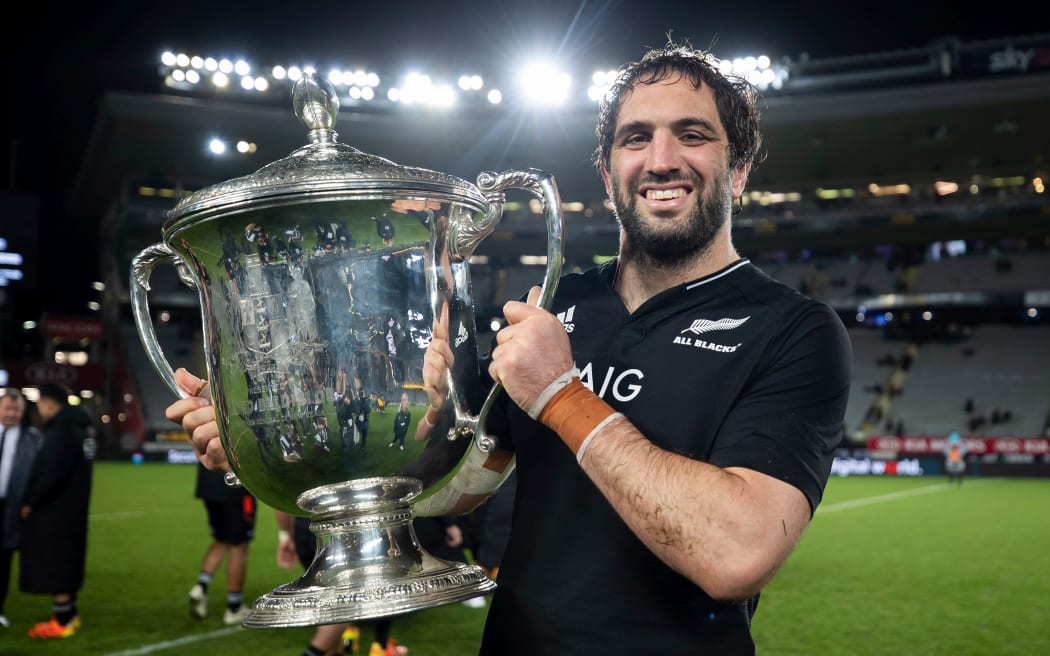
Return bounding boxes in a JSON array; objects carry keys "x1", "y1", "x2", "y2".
[{"x1": 0, "y1": 462, "x2": 1050, "y2": 656}]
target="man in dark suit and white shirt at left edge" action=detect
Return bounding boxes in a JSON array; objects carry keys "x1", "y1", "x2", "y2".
[{"x1": 0, "y1": 387, "x2": 44, "y2": 629}]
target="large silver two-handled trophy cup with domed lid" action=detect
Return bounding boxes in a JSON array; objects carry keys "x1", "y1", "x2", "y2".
[{"x1": 131, "y1": 70, "x2": 563, "y2": 627}]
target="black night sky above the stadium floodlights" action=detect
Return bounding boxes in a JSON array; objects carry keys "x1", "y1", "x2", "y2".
[{"x1": 0, "y1": 0, "x2": 1050, "y2": 311}]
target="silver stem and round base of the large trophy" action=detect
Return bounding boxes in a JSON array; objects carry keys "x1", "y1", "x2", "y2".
[{"x1": 244, "y1": 478, "x2": 496, "y2": 629}]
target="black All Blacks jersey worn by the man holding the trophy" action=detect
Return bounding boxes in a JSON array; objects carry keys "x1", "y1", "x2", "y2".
[{"x1": 482, "y1": 259, "x2": 852, "y2": 656}]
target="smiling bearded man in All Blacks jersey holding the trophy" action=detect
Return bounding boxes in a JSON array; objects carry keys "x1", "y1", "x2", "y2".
[{"x1": 168, "y1": 38, "x2": 851, "y2": 656}]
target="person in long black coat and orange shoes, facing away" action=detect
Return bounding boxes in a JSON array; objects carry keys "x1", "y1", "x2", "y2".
[{"x1": 19, "y1": 383, "x2": 96, "y2": 638}]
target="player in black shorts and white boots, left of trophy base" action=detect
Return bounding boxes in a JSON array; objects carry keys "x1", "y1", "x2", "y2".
[{"x1": 189, "y1": 463, "x2": 255, "y2": 626}]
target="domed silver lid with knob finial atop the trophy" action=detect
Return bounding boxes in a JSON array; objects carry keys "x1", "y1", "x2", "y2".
[{"x1": 163, "y1": 73, "x2": 487, "y2": 229}]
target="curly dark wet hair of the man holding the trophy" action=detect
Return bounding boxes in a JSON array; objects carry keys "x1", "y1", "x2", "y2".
[{"x1": 593, "y1": 41, "x2": 762, "y2": 174}]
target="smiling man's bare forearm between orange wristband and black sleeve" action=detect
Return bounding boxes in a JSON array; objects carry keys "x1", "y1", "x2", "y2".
[{"x1": 581, "y1": 419, "x2": 809, "y2": 599}]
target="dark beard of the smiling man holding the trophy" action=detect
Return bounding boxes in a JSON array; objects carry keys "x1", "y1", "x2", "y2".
[{"x1": 612, "y1": 171, "x2": 733, "y2": 269}]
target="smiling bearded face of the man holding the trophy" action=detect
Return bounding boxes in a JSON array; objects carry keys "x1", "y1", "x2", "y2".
[{"x1": 602, "y1": 76, "x2": 750, "y2": 267}]
